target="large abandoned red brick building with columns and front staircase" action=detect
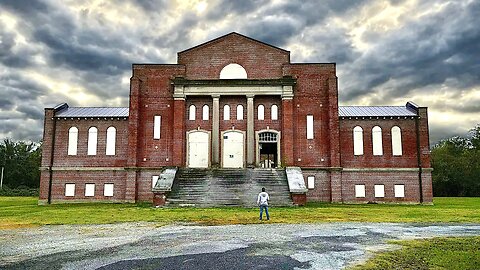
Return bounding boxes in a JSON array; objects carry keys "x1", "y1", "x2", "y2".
[{"x1": 40, "y1": 33, "x2": 432, "y2": 205}]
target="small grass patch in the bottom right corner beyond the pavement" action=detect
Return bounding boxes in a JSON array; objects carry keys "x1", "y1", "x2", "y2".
[{"x1": 351, "y1": 236, "x2": 480, "y2": 270}]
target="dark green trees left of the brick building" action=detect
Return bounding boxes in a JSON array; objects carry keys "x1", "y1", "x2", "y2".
[{"x1": 0, "y1": 139, "x2": 41, "y2": 188}]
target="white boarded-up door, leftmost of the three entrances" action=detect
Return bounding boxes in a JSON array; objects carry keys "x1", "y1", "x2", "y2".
[{"x1": 188, "y1": 131, "x2": 210, "y2": 168}]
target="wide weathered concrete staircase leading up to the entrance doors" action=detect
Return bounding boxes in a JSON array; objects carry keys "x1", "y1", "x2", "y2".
[{"x1": 166, "y1": 168, "x2": 293, "y2": 207}]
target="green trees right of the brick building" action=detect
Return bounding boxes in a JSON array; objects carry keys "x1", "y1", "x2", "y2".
[{"x1": 432, "y1": 125, "x2": 480, "y2": 197}]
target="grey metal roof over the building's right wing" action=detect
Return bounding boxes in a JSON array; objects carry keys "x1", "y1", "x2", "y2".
[{"x1": 338, "y1": 106, "x2": 417, "y2": 117}]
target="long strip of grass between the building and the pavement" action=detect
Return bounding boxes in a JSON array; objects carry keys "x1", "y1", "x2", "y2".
[{"x1": 0, "y1": 197, "x2": 480, "y2": 229}]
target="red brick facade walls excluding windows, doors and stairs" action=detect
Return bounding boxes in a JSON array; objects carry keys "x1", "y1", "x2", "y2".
[{"x1": 40, "y1": 33, "x2": 432, "y2": 203}]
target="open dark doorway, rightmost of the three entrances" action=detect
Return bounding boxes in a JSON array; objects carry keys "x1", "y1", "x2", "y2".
[{"x1": 257, "y1": 130, "x2": 280, "y2": 168}]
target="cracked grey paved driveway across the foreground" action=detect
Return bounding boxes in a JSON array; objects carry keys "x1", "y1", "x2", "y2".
[{"x1": 0, "y1": 223, "x2": 480, "y2": 269}]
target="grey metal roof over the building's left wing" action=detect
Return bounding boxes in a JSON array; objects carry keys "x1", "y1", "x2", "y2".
[{"x1": 55, "y1": 107, "x2": 128, "y2": 117}]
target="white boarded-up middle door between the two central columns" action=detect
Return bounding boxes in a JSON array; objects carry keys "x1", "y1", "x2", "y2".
[{"x1": 222, "y1": 131, "x2": 244, "y2": 168}]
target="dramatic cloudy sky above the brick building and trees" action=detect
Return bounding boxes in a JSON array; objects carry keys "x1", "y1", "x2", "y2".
[{"x1": 0, "y1": 0, "x2": 480, "y2": 142}]
